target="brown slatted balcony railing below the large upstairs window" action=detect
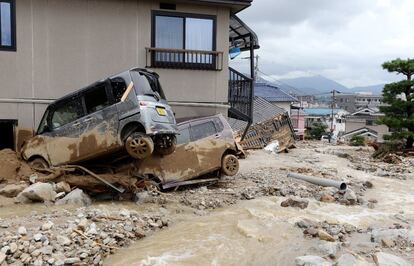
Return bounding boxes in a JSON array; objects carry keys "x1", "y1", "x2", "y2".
[{"x1": 146, "y1": 47, "x2": 223, "y2": 71}]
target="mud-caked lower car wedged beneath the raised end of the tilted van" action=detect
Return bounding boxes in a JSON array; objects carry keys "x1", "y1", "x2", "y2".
[{"x1": 136, "y1": 115, "x2": 239, "y2": 187}]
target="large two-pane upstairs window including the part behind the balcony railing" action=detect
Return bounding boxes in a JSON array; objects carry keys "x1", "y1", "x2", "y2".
[{"x1": 150, "y1": 11, "x2": 218, "y2": 70}]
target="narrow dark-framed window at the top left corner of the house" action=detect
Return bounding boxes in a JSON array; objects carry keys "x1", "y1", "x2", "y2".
[{"x1": 0, "y1": 0, "x2": 16, "y2": 51}]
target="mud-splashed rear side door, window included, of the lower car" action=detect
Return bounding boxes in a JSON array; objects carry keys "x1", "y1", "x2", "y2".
[{"x1": 191, "y1": 119, "x2": 225, "y2": 175}]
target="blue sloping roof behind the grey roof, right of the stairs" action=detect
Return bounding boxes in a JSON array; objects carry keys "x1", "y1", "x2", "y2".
[{"x1": 254, "y1": 82, "x2": 298, "y2": 102}]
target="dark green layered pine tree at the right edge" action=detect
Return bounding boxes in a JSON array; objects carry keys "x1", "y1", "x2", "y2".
[{"x1": 378, "y1": 58, "x2": 414, "y2": 148}]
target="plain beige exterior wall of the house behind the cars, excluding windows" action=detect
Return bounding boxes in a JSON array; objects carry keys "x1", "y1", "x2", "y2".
[{"x1": 0, "y1": 0, "x2": 230, "y2": 128}]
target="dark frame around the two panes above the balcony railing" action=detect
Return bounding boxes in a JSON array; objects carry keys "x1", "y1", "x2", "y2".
[{"x1": 151, "y1": 10, "x2": 217, "y2": 52}]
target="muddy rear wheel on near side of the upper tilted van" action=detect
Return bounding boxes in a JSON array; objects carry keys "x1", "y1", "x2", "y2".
[{"x1": 125, "y1": 132, "x2": 154, "y2": 160}]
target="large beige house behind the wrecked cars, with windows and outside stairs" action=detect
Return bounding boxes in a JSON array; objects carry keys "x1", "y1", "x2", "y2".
[{"x1": 0, "y1": 0, "x2": 259, "y2": 150}]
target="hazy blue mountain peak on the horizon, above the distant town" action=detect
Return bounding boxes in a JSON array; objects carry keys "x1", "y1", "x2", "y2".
[{"x1": 280, "y1": 75, "x2": 349, "y2": 95}]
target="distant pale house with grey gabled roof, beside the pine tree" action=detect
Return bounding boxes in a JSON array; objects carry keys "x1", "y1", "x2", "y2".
[{"x1": 343, "y1": 108, "x2": 389, "y2": 142}]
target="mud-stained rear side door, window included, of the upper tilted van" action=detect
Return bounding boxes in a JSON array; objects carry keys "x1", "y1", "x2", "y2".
[{"x1": 78, "y1": 80, "x2": 120, "y2": 160}]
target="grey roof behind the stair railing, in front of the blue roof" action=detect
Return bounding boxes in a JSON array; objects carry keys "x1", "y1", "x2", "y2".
[{"x1": 228, "y1": 96, "x2": 286, "y2": 131}]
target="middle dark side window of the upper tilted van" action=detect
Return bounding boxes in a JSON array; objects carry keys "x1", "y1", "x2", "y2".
[{"x1": 84, "y1": 83, "x2": 110, "y2": 114}]
